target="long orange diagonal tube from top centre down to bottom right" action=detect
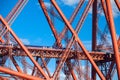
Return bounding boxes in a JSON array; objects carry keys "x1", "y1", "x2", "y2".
[{"x1": 51, "y1": 0, "x2": 105, "y2": 80}]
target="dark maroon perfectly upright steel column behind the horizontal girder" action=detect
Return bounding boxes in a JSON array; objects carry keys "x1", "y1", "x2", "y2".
[{"x1": 91, "y1": 0, "x2": 97, "y2": 80}]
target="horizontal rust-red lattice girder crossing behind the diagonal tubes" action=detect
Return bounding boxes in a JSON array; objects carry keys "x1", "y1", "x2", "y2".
[{"x1": 0, "y1": 45, "x2": 114, "y2": 61}]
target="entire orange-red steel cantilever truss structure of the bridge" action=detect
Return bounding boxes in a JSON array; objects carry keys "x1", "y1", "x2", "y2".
[{"x1": 0, "y1": 0, "x2": 120, "y2": 80}]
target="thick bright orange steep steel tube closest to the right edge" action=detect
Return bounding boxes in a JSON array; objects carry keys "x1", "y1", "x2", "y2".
[{"x1": 106, "y1": 0, "x2": 120, "y2": 80}]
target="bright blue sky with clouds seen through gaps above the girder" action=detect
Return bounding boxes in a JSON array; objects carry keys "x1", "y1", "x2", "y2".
[{"x1": 0, "y1": 0, "x2": 120, "y2": 79}]
